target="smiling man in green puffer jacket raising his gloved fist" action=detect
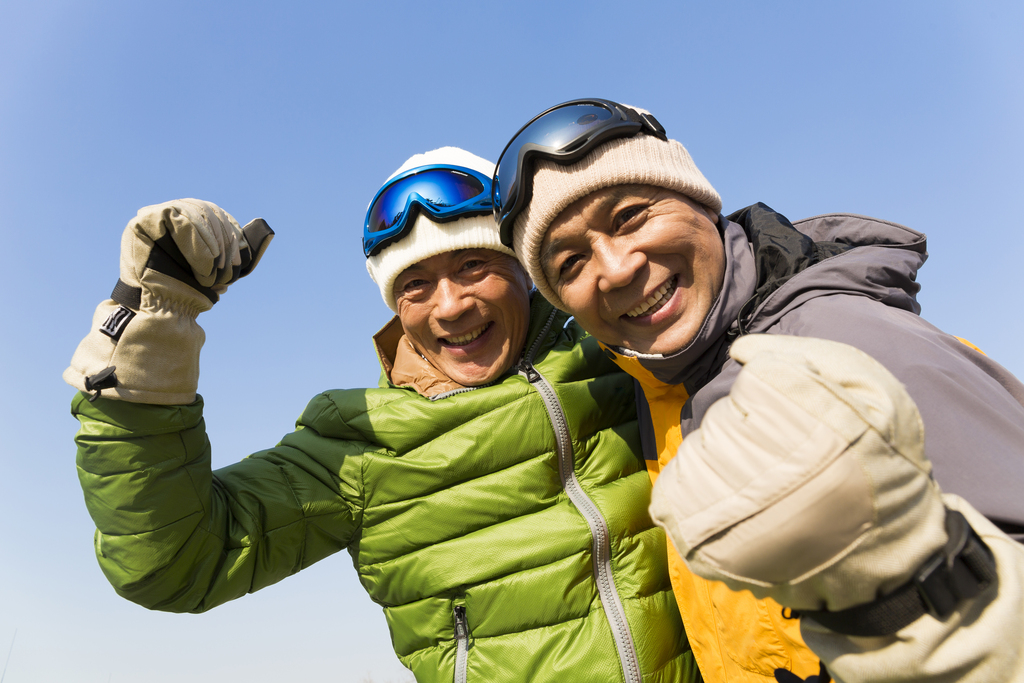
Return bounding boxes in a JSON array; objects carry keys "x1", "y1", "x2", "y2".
[{"x1": 65, "y1": 147, "x2": 698, "y2": 683}]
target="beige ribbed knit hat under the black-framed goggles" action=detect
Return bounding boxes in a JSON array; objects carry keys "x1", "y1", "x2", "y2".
[{"x1": 512, "y1": 104, "x2": 722, "y2": 310}]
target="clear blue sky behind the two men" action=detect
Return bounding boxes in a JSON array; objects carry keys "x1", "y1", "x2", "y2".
[{"x1": 0, "y1": 0, "x2": 1024, "y2": 683}]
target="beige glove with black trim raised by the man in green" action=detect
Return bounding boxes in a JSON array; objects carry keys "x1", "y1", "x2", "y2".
[{"x1": 63, "y1": 199, "x2": 273, "y2": 404}]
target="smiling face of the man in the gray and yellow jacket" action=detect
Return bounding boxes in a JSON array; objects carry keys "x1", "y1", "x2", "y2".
[{"x1": 541, "y1": 185, "x2": 725, "y2": 353}]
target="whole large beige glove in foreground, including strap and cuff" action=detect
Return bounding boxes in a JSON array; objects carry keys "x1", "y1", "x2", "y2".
[{"x1": 651, "y1": 335, "x2": 1024, "y2": 683}]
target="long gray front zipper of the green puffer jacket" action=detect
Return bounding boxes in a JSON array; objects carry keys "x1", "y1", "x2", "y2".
[{"x1": 520, "y1": 311, "x2": 643, "y2": 683}]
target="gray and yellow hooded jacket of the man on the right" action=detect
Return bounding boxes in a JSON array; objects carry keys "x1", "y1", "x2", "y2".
[{"x1": 608, "y1": 205, "x2": 1024, "y2": 683}]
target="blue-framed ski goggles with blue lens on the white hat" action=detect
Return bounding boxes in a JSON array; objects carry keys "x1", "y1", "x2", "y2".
[{"x1": 362, "y1": 164, "x2": 492, "y2": 258}]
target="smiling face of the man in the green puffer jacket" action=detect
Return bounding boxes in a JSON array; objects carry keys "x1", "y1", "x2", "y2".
[{"x1": 394, "y1": 249, "x2": 530, "y2": 386}]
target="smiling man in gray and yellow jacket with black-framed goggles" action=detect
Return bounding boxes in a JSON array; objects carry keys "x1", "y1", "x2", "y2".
[{"x1": 495, "y1": 99, "x2": 1024, "y2": 681}]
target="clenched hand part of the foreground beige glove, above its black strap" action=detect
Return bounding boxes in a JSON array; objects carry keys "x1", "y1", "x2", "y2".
[{"x1": 650, "y1": 335, "x2": 947, "y2": 611}]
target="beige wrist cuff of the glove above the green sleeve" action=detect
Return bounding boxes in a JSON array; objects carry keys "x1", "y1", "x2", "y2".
[{"x1": 63, "y1": 299, "x2": 206, "y2": 405}]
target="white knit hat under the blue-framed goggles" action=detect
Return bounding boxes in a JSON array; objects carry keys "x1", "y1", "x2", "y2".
[{"x1": 367, "y1": 147, "x2": 515, "y2": 312}]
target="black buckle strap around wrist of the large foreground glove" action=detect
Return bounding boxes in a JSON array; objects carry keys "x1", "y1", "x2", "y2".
[{"x1": 801, "y1": 509, "x2": 996, "y2": 636}]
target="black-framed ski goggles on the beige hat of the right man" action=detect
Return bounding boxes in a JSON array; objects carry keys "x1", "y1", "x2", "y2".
[{"x1": 492, "y1": 99, "x2": 669, "y2": 248}]
